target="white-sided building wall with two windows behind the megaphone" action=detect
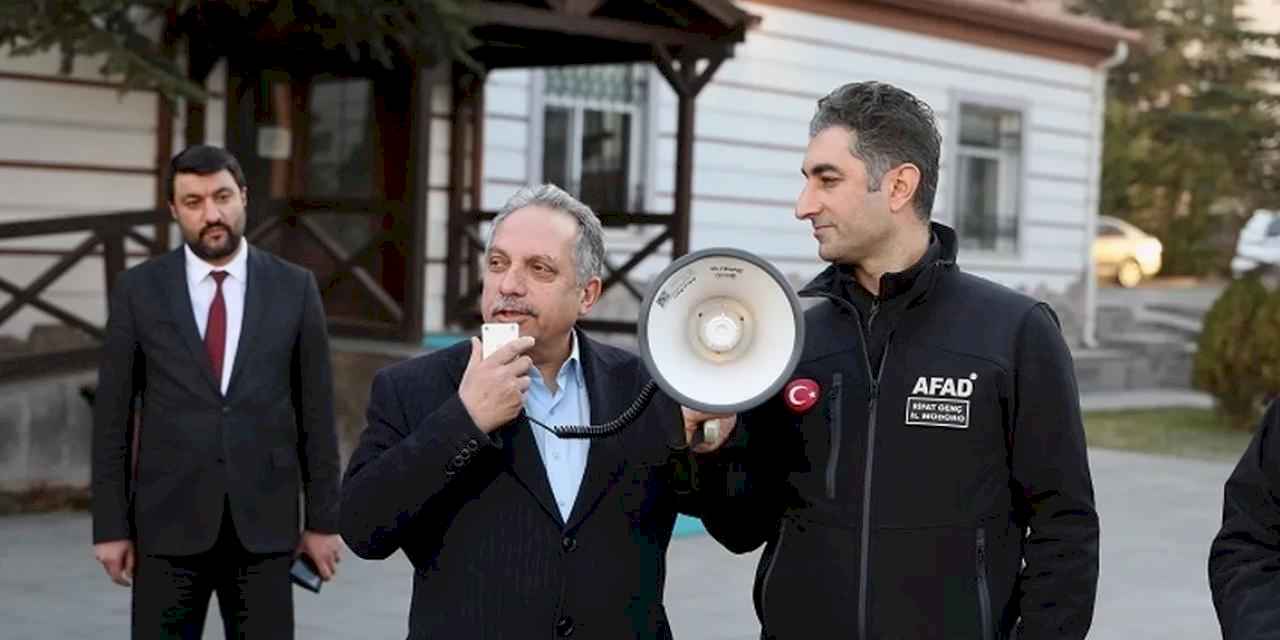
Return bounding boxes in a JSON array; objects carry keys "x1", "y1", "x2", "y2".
[{"x1": 471, "y1": 0, "x2": 1135, "y2": 343}]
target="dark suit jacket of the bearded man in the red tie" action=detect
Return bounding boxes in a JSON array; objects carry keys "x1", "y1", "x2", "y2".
[{"x1": 92, "y1": 247, "x2": 339, "y2": 556}]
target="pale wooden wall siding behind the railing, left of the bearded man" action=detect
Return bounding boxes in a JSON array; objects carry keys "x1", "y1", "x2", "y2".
[{"x1": 0, "y1": 50, "x2": 225, "y2": 339}]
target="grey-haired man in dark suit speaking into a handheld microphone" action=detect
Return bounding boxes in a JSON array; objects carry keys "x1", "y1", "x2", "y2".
[{"x1": 342, "y1": 184, "x2": 728, "y2": 640}]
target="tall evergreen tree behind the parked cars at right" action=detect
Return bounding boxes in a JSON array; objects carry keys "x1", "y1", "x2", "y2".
[{"x1": 1073, "y1": 0, "x2": 1277, "y2": 275}]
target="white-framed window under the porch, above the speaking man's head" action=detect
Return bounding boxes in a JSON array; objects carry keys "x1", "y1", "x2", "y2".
[{"x1": 534, "y1": 64, "x2": 649, "y2": 212}]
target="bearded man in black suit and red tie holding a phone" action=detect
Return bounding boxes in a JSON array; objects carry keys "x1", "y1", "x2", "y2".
[{"x1": 92, "y1": 146, "x2": 340, "y2": 639}]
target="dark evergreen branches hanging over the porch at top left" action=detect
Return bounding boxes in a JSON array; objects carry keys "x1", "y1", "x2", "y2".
[{"x1": 0, "y1": 0, "x2": 475, "y2": 100}]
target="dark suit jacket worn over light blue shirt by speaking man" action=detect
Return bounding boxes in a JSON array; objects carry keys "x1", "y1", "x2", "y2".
[{"x1": 342, "y1": 333, "x2": 698, "y2": 640}]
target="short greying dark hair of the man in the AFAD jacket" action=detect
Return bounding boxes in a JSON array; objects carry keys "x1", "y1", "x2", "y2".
[{"x1": 809, "y1": 82, "x2": 942, "y2": 221}]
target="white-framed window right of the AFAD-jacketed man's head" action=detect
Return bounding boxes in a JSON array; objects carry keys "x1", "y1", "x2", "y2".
[{"x1": 952, "y1": 102, "x2": 1025, "y2": 253}]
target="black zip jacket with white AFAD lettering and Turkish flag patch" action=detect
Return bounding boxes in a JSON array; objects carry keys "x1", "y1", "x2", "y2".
[{"x1": 699, "y1": 224, "x2": 1098, "y2": 640}]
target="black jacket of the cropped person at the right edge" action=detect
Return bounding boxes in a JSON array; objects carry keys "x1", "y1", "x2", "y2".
[{"x1": 1208, "y1": 402, "x2": 1280, "y2": 640}]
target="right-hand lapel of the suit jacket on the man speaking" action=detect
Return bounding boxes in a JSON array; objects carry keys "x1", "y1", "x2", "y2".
[{"x1": 567, "y1": 332, "x2": 632, "y2": 529}]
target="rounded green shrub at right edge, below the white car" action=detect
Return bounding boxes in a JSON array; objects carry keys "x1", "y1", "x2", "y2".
[{"x1": 1192, "y1": 273, "x2": 1280, "y2": 429}]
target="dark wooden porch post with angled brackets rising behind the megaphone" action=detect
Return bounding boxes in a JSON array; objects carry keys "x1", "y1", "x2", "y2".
[{"x1": 654, "y1": 45, "x2": 724, "y2": 257}]
